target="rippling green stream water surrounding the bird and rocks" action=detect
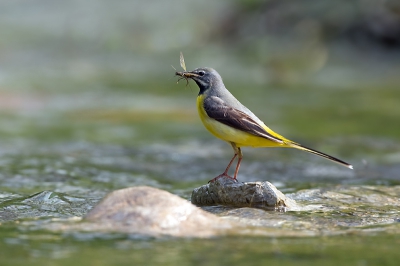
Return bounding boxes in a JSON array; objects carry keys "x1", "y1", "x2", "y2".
[{"x1": 0, "y1": 1, "x2": 400, "y2": 265}]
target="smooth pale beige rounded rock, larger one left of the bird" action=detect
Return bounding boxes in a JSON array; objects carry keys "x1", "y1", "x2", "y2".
[{"x1": 82, "y1": 186, "x2": 231, "y2": 237}]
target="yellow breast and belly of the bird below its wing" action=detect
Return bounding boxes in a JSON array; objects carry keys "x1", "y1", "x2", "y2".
[{"x1": 197, "y1": 95, "x2": 281, "y2": 147}]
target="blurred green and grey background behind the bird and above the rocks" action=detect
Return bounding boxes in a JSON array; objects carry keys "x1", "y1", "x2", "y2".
[{"x1": 0, "y1": 0, "x2": 400, "y2": 264}]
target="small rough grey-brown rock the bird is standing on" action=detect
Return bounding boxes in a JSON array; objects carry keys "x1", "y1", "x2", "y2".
[{"x1": 191, "y1": 177, "x2": 296, "y2": 210}]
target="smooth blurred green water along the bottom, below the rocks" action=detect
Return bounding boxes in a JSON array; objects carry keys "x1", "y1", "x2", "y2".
[{"x1": 0, "y1": 227, "x2": 399, "y2": 265}]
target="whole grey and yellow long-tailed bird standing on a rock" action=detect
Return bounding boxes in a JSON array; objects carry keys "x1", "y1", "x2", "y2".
[{"x1": 175, "y1": 68, "x2": 353, "y2": 182}]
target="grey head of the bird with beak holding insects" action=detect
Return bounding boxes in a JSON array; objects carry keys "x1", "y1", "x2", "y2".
[{"x1": 175, "y1": 67, "x2": 222, "y2": 94}]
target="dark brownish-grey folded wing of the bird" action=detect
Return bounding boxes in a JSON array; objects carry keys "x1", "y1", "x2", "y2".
[{"x1": 204, "y1": 96, "x2": 283, "y2": 143}]
